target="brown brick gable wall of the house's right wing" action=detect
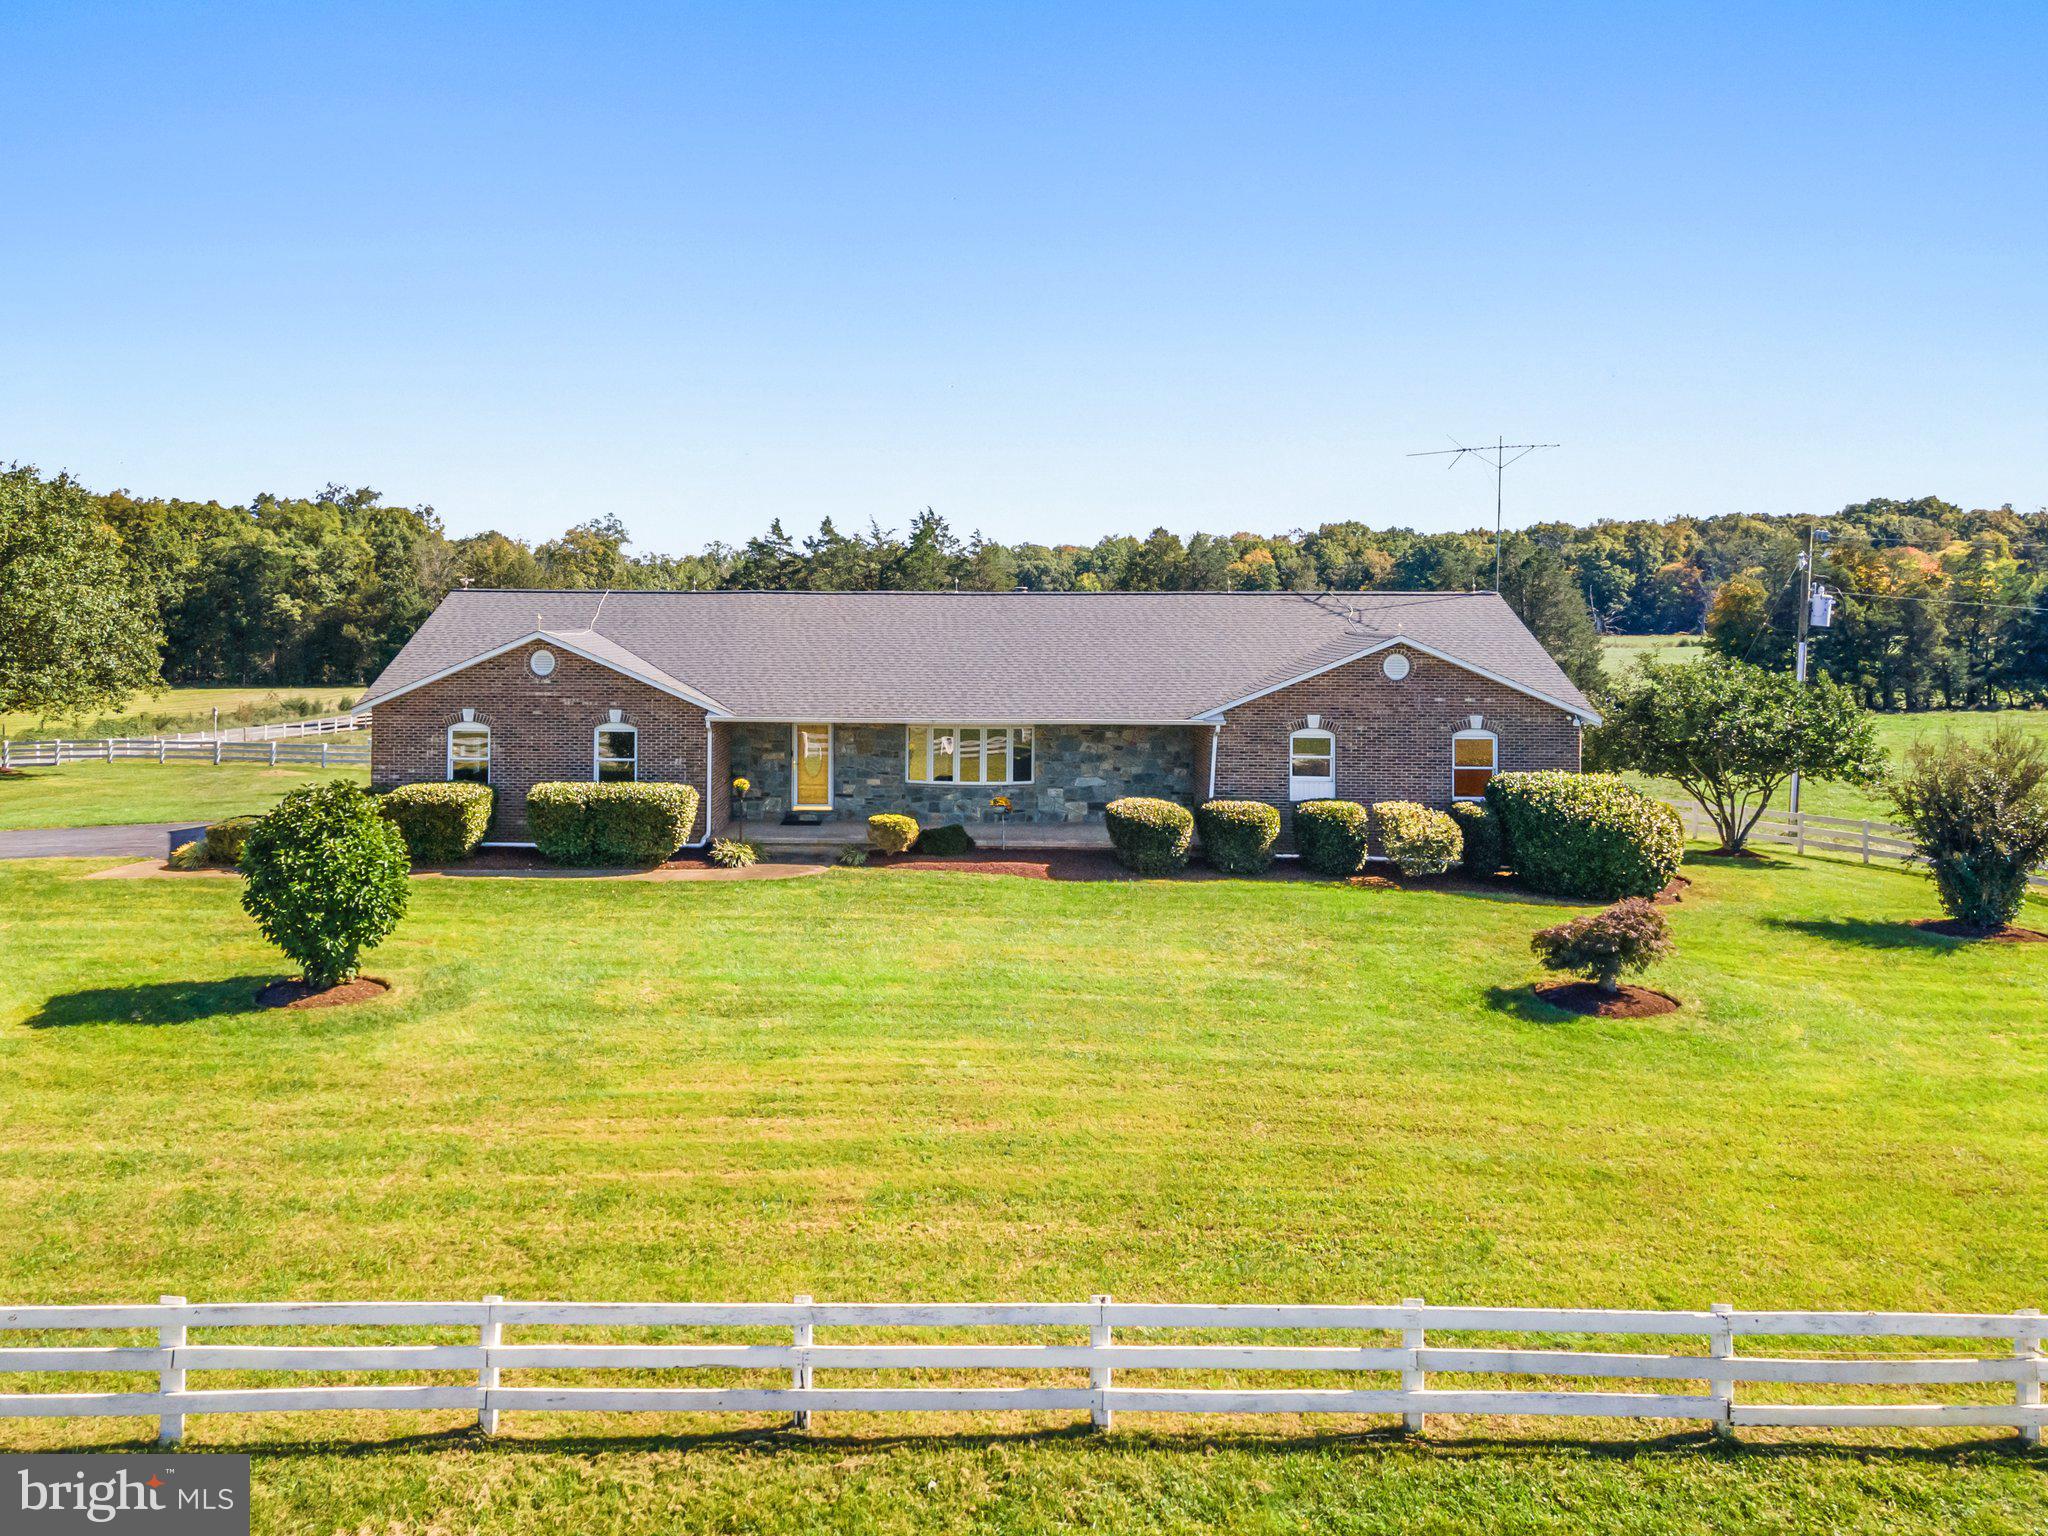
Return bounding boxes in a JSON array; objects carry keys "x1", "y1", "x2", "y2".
[{"x1": 1217, "y1": 649, "x2": 1579, "y2": 835}]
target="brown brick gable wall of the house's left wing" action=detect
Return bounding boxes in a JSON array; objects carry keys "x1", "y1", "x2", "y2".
[{"x1": 371, "y1": 645, "x2": 723, "y2": 842}]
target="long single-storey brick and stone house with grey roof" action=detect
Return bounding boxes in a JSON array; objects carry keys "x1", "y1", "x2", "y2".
[{"x1": 365, "y1": 592, "x2": 1599, "y2": 846}]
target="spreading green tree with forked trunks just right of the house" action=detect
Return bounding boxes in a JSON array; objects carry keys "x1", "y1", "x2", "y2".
[{"x1": 1585, "y1": 657, "x2": 1884, "y2": 854}]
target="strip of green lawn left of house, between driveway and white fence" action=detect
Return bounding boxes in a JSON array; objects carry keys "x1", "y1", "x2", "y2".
[{"x1": 0, "y1": 761, "x2": 371, "y2": 831}]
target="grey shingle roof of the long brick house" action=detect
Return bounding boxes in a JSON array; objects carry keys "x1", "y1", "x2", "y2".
[{"x1": 365, "y1": 592, "x2": 1593, "y2": 723}]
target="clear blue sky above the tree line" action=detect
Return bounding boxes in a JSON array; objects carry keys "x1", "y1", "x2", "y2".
[{"x1": 0, "y1": 0, "x2": 2048, "y2": 549}]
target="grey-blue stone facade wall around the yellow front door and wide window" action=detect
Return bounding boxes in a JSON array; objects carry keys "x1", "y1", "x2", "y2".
[{"x1": 721, "y1": 725, "x2": 1208, "y2": 823}]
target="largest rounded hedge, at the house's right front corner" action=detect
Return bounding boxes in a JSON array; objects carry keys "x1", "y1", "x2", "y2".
[{"x1": 1487, "y1": 768, "x2": 1686, "y2": 901}]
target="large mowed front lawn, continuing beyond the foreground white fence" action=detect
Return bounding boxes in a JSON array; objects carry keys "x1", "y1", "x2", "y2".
[{"x1": 0, "y1": 860, "x2": 2048, "y2": 1534}]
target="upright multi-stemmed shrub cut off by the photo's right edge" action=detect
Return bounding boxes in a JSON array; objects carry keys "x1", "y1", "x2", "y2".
[{"x1": 1888, "y1": 725, "x2": 2048, "y2": 932}]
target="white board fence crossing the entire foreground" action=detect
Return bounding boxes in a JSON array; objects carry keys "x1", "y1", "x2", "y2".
[{"x1": 0, "y1": 1296, "x2": 2044, "y2": 1444}]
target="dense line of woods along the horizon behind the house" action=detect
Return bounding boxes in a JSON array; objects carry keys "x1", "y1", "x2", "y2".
[{"x1": 0, "y1": 465, "x2": 2048, "y2": 709}]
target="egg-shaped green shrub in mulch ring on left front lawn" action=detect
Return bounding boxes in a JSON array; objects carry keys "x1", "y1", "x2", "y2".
[{"x1": 242, "y1": 780, "x2": 410, "y2": 987}]
